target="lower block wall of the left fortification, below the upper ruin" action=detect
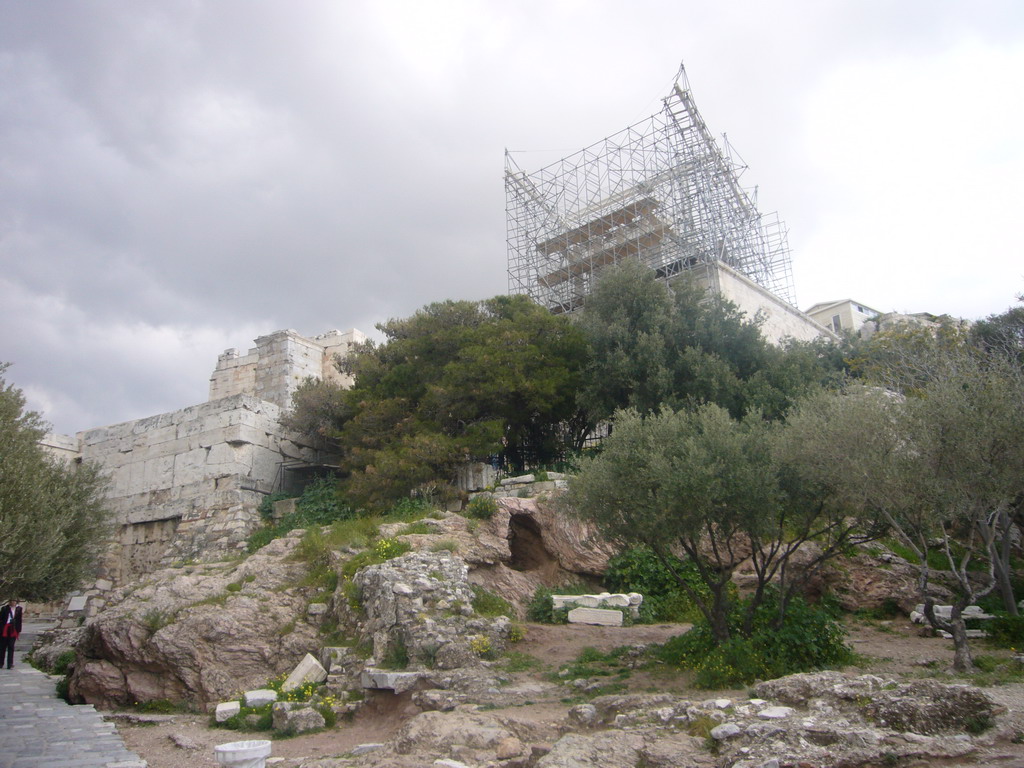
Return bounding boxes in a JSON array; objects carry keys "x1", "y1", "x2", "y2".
[{"x1": 79, "y1": 394, "x2": 312, "y2": 581}]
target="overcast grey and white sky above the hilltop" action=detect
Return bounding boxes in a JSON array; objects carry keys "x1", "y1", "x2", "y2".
[{"x1": 0, "y1": 0, "x2": 1024, "y2": 433}]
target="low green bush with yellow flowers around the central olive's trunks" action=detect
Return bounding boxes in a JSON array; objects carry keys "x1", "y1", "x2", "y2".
[{"x1": 657, "y1": 593, "x2": 853, "y2": 689}]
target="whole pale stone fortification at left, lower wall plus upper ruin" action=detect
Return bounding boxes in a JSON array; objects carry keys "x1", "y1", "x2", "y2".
[{"x1": 43, "y1": 330, "x2": 367, "y2": 584}]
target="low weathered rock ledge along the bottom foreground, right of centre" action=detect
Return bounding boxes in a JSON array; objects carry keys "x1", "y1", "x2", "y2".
[{"x1": 303, "y1": 673, "x2": 997, "y2": 768}]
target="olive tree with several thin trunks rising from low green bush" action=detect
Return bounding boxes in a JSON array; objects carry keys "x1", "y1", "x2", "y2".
[{"x1": 568, "y1": 404, "x2": 881, "y2": 643}]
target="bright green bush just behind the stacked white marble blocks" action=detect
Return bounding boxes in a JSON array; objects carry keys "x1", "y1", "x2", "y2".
[{"x1": 604, "y1": 547, "x2": 711, "y2": 622}]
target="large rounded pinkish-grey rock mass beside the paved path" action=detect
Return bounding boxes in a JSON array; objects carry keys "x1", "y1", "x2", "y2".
[{"x1": 70, "y1": 531, "x2": 317, "y2": 709}]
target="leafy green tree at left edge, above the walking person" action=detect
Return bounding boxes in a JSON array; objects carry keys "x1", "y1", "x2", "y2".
[{"x1": 0, "y1": 364, "x2": 110, "y2": 601}]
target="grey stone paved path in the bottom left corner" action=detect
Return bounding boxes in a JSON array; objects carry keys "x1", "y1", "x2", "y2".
[{"x1": 0, "y1": 622, "x2": 146, "y2": 768}]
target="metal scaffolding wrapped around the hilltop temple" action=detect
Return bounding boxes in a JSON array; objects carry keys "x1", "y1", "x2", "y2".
[{"x1": 505, "y1": 68, "x2": 796, "y2": 312}]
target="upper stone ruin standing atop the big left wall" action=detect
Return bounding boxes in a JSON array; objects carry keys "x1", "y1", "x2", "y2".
[{"x1": 210, "y1": 329, "x2": 367, "y2": 408}]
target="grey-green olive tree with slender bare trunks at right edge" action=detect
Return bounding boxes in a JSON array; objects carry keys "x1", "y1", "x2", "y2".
[{"x1": 786, "y1": 362, "x2": 1024, "y2": 671}]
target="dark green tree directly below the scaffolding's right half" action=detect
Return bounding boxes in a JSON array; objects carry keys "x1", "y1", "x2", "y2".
[{"x1": 580, "y1": 261, "x2": 841, "y2": 419}]
